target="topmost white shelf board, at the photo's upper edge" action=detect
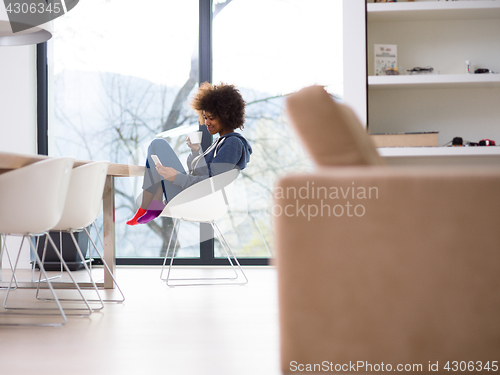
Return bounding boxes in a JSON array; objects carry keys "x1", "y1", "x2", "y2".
[{"x1": 367, "y1": 1, "x2": 500, "y2": 22}]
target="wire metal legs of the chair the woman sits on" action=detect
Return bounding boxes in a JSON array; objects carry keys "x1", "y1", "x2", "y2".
[{"x1": 160, "y1": 219, "x2": 248, "y2": 287}]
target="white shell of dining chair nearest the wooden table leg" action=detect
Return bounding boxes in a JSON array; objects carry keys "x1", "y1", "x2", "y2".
[{"x1": 53, "y1": 161, "x2": 109, "y2": 230}]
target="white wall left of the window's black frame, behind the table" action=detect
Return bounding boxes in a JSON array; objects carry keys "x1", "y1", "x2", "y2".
[{"x1": 0, "y1": 46, "x2": 36, "y2": 268}]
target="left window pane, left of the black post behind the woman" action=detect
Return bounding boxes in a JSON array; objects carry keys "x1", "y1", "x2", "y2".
[{"x1": 49, "y1": 0, "x2": 199, "y2": 258}]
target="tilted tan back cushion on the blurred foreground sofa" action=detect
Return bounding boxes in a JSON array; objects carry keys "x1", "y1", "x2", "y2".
[{"x1": 286, "y1": 86, "x2": 385, "y2": 166}]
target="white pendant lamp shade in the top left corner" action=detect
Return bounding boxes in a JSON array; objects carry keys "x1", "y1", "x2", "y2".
[{"x1": 0, "y1": 0, "x2": 52, "y2": 46}]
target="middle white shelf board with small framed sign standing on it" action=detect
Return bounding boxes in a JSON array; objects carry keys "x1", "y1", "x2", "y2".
[{"x1": 368, "y1": 74, "x2": 500, "y2": 90}]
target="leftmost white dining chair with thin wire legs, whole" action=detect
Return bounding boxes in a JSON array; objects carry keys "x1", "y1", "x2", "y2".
[{"x1": 0, "y1": 158, "x2": 85, "y2": 326}]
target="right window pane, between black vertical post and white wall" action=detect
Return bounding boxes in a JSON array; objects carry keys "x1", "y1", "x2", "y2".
[{"x1": 213, "y1": 0, "x2": 343, "y2": 257}]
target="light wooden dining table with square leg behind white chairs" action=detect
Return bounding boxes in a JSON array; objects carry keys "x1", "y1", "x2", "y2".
[{"x1": 0, "y1": 151, "x2": 144, "y2": 289}]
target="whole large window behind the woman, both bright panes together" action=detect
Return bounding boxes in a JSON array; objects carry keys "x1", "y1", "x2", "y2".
[{"x1": 48, "y1": 0, "x2": 342, "y2": 264}]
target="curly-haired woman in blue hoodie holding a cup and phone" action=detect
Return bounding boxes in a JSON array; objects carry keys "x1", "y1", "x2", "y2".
[{"x1": 127, "y1": 82, "x2": 252, "y2": 225}]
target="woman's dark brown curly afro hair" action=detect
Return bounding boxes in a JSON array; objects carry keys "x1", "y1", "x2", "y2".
[{"x1": 191, "y1": 82, "x2": 246, "y2": 130}]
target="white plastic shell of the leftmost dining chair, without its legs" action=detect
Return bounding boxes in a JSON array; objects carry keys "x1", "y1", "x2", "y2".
[{"x1": 0, "y1": 158, "x2": 74, "y2": 234}]
